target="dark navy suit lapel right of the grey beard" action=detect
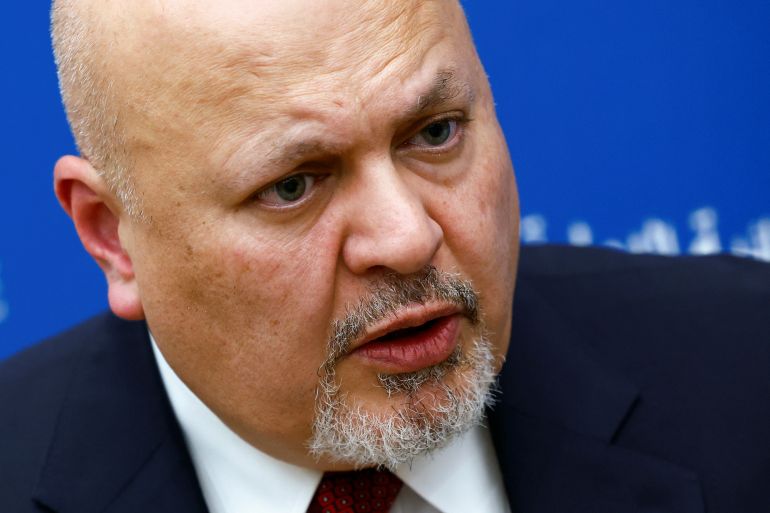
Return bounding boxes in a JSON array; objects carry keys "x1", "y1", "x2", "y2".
[{"x1": 489, "y1": 278, "x2": 703, "y2": 513}]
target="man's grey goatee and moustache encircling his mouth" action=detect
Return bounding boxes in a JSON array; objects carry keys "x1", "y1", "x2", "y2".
[{"x1": 308, "y1": 267, "x2": 495, "y2": 470}]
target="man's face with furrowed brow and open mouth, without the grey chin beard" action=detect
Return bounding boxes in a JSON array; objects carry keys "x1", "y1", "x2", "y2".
[{"x1": 113, "y1": 0, "x2": 518, "y2": 468}]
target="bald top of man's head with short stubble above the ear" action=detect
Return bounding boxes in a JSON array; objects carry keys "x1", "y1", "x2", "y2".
[{"x1": 51, "y1": 0, "x2": 472, "y2": 217}]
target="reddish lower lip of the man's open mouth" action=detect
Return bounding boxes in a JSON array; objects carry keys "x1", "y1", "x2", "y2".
[{"x1": 353, "y1": 315, "x2": 460, "y2": 373}]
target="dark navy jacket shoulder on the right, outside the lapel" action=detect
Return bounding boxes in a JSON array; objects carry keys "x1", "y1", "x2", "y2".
[{"x1": 511, "y1": 246, "x2": 770, "y2": 511}]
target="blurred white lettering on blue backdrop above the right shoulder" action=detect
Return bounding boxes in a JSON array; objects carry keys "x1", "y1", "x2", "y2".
[{"x1": 521, "y1": 207, "x2": 770, "y2": 262}]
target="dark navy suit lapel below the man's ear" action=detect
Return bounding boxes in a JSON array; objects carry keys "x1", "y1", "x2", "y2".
[{"x1": 34, "y1": 316, "x2": 206, "y2": 513}]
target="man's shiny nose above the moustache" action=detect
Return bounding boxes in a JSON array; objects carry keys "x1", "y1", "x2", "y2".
[{"x1": 342, "y1": 165, "x2": 444, "y2": 274}]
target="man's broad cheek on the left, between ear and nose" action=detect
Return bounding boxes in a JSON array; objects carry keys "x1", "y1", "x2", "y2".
[{"x1": 136, "y1": 218, "x2": 336, "y2": 432}]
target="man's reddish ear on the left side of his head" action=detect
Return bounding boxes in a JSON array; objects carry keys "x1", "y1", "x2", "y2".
[{"x1": 54, "y1": 156, "x2": 144, "y2": 320}]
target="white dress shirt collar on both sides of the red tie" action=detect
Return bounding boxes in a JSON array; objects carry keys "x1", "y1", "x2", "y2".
[{"x1": 150, "y1": 336, "x2": 510, "y2": 513}]
